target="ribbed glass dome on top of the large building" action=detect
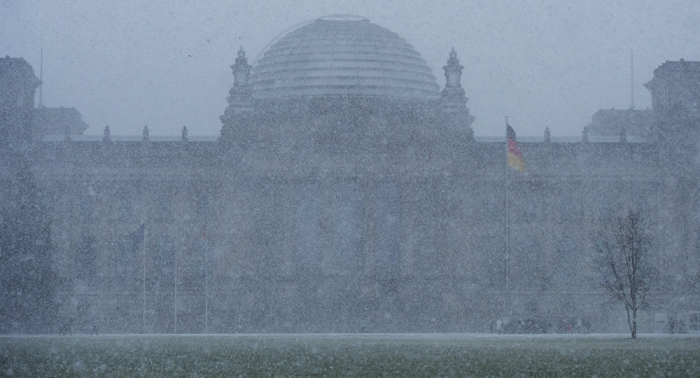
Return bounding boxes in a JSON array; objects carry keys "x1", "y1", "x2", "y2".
[{"x1": 250, "y1": 17, "x2": 440, "y2": 100}]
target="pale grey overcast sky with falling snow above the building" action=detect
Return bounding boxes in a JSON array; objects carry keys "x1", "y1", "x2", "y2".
[{"x1": 0, "y1": 0, "x2": 700, "y2": 136}]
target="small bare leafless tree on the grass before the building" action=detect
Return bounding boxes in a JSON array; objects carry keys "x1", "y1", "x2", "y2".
[{"x1": 593, "y1": 208, "x2": 658, "y2": 339}]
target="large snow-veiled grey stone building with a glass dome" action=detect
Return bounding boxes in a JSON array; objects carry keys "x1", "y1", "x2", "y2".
[{"x1": 3, "y1": 17, "x2": 700, "y2": 333}]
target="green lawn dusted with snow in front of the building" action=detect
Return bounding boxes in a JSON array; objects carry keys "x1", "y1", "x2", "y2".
[{"x1": 0, "y1": 334, "x2": 700, "y2": 377}]
